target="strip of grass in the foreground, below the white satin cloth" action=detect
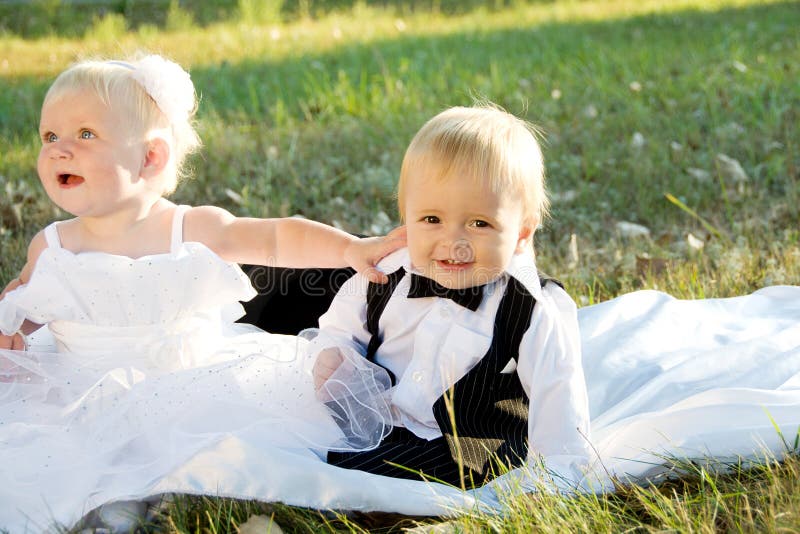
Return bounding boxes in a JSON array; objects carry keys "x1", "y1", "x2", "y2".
[{"x1": 152, "y1": 456, "x2": 800, "y2": 534}]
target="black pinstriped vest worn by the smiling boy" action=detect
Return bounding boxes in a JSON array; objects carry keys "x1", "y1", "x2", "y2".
[{"x1": 366, "y1": 268, "x2": 546, "y2": 484}]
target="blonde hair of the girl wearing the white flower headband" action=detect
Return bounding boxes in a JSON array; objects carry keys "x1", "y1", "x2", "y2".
[{"x1": 44, "y1": 56, "x2": 201, "y2": 195}]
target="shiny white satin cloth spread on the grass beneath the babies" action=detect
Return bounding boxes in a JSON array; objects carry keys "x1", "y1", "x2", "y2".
[{"x1": 7, "y1": 286, "x2": 800, "y2": 524}]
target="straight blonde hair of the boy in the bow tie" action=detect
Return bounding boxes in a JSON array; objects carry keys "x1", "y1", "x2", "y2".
[{"x1": 397, "y1": 104, "x2": 549, "y2": 226}]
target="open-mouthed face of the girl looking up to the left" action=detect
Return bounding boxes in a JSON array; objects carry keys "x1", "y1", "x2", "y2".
[{"x1": 38, "y1": 90, "x2": 152, "y2": 217}]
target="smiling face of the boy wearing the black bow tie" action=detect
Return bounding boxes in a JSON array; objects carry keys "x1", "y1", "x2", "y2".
[{"x1": 405, "y1": 175, "x2": 534, "y2": 289}]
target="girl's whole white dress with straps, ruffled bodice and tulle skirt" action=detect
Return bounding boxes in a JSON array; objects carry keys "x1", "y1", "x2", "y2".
[{"x1": 0, "y1": 208, "x2": 389, "y2": 532}]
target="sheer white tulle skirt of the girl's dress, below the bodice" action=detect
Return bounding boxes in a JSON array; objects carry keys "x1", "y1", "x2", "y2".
[{"x1": 0, "y1": 328, "x2": 390, "y2": 530}]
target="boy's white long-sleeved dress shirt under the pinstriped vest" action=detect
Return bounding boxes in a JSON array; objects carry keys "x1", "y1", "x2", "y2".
[{"x1": 309, "y1": 249, "x2": 592, "y2": 492}]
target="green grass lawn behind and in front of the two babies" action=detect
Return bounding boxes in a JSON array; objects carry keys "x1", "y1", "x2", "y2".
[{"x1": 0, "y1": 0, "x2": 800, "y2": 532}]
